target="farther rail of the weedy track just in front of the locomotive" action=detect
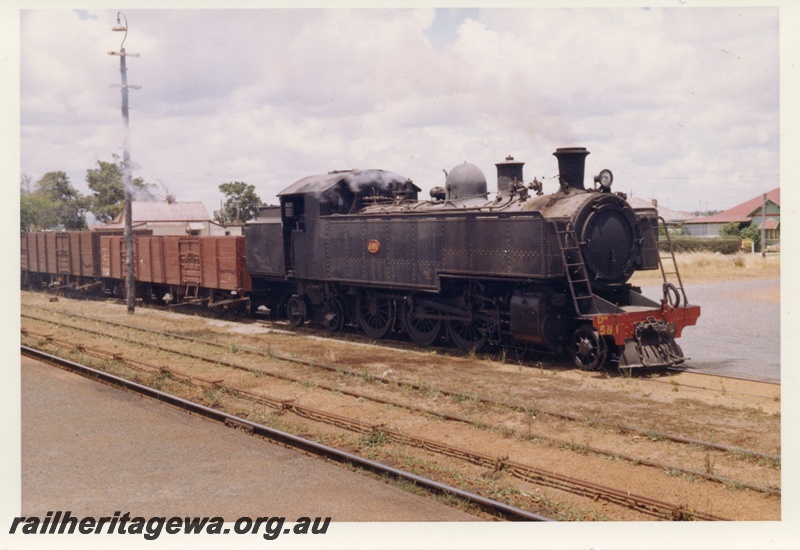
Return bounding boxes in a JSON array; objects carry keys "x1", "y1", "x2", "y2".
[{"x1": 23, "y1": 313, "x2": 781, "y2": 468}]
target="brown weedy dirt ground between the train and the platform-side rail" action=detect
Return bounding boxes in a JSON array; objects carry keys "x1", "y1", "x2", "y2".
[{"x1": 22, "y1": 292, "x2": 781, "y2": 520}]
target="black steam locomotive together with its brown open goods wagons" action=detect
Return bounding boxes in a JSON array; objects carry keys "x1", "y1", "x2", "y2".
[{"x1": 22, "y1": 147, "x2": 700, "y2": 370}]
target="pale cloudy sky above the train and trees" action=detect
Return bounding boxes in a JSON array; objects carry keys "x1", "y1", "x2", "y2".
[{"x1": 12, "y1": 2, "x2": 781, "y2": 220}]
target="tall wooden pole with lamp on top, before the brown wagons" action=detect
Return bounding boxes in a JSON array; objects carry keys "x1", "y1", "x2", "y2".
[{"x1": 108, "y1": 12, "x2": 141, "y2": 315}]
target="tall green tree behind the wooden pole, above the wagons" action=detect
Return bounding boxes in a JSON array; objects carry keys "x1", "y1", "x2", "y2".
[{"x1": 86, "y1": 155, "x2": 155, "y2": 223}]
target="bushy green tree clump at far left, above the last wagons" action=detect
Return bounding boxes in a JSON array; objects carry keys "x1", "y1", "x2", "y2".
[{"x1": 20, "y1": 172, "x2": 87, "y2": 231}]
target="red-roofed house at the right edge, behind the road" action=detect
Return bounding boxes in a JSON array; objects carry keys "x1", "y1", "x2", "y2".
[{"x1": 683, "y1": 187, "x2": 781, "y2": 246}]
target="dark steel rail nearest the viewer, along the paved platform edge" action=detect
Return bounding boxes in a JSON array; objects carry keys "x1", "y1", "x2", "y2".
[{"x1": 20, "y1": 346, "x2": 553, "y2": 521}]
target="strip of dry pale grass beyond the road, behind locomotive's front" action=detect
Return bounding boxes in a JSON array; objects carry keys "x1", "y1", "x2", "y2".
[{"x1": 631, "y1": 252, "x2": 781, "y2": 285}]
